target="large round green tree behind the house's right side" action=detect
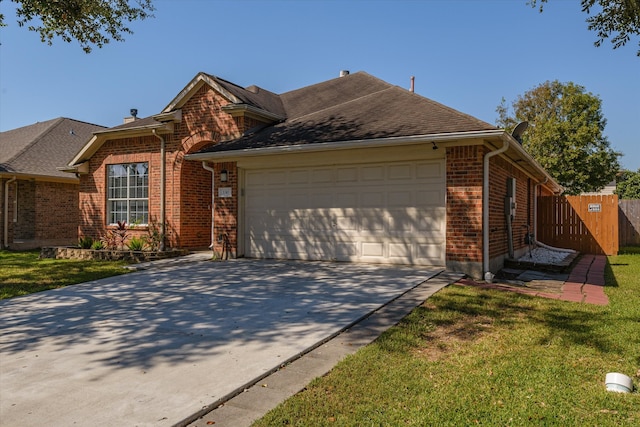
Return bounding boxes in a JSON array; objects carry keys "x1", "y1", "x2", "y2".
[{"x1": 496, "y1": 80, "x2": 621, "y2": 194}]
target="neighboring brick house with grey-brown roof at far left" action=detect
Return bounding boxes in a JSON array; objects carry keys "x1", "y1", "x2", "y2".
[{"x1": 0, "y1": 118, "x2": 104, "y2": 249}]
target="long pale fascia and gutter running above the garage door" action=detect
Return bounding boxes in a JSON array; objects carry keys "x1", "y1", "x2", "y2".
[{"x1": 184, "y1": 130, "x2": 504, "y2": 161}]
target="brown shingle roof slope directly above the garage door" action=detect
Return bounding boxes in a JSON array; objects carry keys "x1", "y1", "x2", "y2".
[{"x1": 195, "y1": 72, "x2": 497, "y2": 153}]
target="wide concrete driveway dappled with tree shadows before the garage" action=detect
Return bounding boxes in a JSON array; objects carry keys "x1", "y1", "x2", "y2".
[{"x1": 0, "y1": 260, "x2": 441, "y2": 427}]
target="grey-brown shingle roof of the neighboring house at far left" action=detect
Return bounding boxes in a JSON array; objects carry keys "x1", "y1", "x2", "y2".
[{"x1": 0, "y1": 117, "x2": 105, "y2": 178}]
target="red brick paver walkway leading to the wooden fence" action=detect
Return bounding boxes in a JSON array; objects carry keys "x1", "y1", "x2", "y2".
[{"x1": 456, "y1": 255, "x2": 609, "y2": 305}]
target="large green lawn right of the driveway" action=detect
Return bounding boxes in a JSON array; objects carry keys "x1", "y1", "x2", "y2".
[{"x1": 255, "y1": 248, "x2": 640, "y2": 426}]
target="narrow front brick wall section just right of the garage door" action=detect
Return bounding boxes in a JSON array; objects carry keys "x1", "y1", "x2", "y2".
[{"x1": 446, "y1": 146, "x2": 485, "y2": 262}]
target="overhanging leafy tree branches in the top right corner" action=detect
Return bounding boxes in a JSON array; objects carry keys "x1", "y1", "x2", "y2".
[{"x1": 529, "y1": 0, "x2": 640, "y2": 56}]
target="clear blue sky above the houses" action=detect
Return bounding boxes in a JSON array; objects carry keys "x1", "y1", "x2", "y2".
[{"x1": 0, "y1": 0, "x2": 640, "y2": 170}]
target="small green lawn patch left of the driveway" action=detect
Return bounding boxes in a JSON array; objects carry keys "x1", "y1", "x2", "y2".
[{"x1": 0, "y1": 251, "x2": 127, "y2": 299}]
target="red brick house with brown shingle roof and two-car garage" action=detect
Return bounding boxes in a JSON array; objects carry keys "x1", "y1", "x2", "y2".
[{"x1": 63, "y1": 72, "x2": 562, "y2": 277}]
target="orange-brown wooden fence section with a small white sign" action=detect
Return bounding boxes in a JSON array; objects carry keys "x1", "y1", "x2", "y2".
[{"x1": 537, "y1": 195, "x2": 618, "y2": 255}]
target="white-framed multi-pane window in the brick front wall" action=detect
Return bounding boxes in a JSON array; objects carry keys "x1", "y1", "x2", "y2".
[{"x1": 107, "y1": 162, "x2": 149, "y2": 225}]
